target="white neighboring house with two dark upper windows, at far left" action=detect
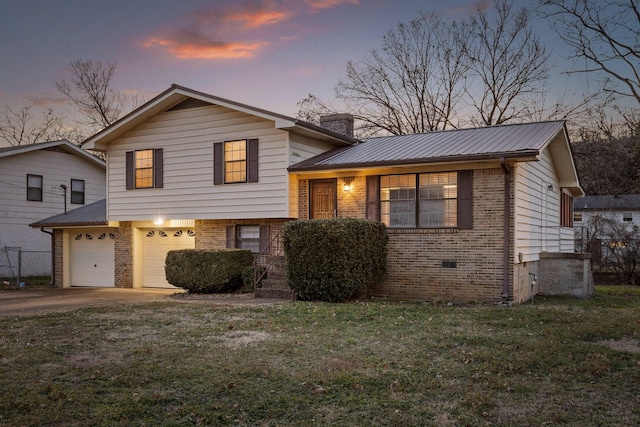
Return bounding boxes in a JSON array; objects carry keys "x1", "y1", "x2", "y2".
[{"x1": 0, "y1": 140, "x2": 106, "y2": 278}]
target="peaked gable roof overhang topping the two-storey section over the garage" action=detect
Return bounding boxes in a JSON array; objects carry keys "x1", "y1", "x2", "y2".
[{"x1": 82, "y1": 84, "x2": 358, "y2": 151}]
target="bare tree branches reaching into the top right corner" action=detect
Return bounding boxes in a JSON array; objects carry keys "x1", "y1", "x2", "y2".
[{"x1": 541, "y1": 0, "x2": 640, "y2": 104}]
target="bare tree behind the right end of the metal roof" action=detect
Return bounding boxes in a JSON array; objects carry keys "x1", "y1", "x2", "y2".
[{"x1": 467, "y1": 0, "x2": 549, "y2": 126}]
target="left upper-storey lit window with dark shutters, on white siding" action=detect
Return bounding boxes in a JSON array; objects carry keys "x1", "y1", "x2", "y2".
[{"x1": 126, "y1": 148, "x2": 163, "y2": 190}]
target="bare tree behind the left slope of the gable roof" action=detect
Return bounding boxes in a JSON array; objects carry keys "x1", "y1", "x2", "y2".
[{"x1": 56, "y1": 60, "x2": 143, "y2": 130}]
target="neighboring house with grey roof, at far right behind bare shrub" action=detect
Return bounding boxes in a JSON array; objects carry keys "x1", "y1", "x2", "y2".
[{"x1": 573, "y1": 194, "x2": 640, "y2": 261}]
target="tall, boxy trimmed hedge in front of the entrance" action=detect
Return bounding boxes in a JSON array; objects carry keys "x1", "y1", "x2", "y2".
[{"x1": 283, "y1": 218, "x2": 389, "y2": 302}]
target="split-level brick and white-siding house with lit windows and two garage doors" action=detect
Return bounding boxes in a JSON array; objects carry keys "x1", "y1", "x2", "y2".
[{"x1": 34, "y1": 85, "x2": 591, "y2": 302}]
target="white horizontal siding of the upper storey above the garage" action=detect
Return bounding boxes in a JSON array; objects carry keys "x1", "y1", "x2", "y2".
[{"x1": 107, "y1": 106, "x2": 289, "y2": 221}]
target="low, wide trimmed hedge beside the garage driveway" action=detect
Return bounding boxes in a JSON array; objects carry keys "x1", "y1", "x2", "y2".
[{"x1": 164, "y1": 249, "x2": 253, "y2": 294}]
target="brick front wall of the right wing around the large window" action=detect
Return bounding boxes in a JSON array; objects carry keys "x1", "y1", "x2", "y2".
[{"x1": 300, "y1": 168, "x2": 513, "y2": 302}]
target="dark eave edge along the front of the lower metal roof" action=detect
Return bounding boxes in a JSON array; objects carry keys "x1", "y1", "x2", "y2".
[{"x1": 288, "y1": 150, "x2": 540, "y2": 172}]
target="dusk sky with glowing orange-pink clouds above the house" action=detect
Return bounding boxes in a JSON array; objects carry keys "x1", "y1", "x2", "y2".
[{"x1": 0, "y1": 0, "x2": 592, "y2": 122}]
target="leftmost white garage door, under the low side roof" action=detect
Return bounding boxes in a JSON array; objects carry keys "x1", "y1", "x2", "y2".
[{"x1": 69, "y1": 228, "x2": 116, "y2": 287}]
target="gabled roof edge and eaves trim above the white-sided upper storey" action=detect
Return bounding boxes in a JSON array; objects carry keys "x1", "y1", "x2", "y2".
[{"x1": 81, "y1": 83, "x2": 360, "y2": 150}]
